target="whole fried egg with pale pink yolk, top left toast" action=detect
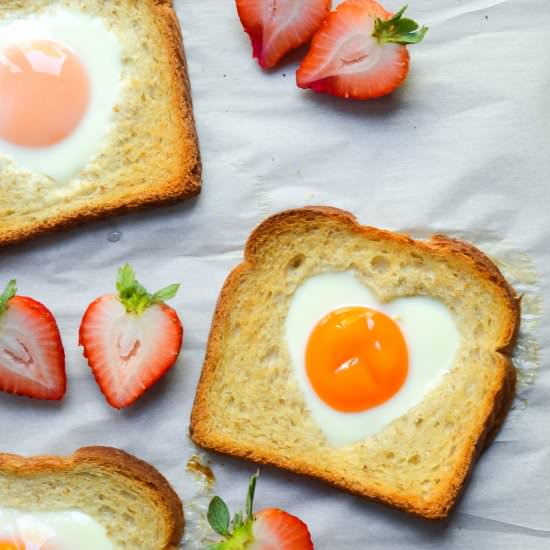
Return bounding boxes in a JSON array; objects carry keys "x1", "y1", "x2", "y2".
[{"x1": 0, "y1": 10, "x2": 122, "y2": 182}]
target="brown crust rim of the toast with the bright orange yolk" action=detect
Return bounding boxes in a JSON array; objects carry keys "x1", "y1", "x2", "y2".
[{"x1": 189, "y1": 206, "x2": 520, "y2": 520}]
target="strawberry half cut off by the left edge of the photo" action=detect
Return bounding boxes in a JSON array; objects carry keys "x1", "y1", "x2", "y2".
[{"x1": 0, "y1": 280, "x2": 67, "y2": 400}]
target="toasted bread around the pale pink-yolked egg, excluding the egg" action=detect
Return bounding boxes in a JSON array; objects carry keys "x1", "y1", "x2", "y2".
[{"x1": 0, "y1": 0, "x2": 201, "y2": 246}]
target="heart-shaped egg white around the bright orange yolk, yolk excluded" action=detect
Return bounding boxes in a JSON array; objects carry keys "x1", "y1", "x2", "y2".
[{"x1": 285, "y1": 271, "x2": 460, "y2": 447}]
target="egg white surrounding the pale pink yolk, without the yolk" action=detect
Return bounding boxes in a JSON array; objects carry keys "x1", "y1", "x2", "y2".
[{"x1": 0, "y1": 10, "x2": 122, "y2": 184}]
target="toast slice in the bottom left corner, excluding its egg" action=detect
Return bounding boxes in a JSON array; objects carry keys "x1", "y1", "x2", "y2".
[{"x1": 0, "y1": 447, "x2": 184, "y2": 550}]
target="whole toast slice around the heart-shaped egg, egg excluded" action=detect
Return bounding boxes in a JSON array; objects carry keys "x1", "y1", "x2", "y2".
[{"x1": 190, "y1": 207, "x2": 519, "y2": 519}]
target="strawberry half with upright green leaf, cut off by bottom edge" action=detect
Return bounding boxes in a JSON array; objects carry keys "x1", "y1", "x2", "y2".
[{"x1": 208, "y1": 473, "x2": 313, "y2": 550}]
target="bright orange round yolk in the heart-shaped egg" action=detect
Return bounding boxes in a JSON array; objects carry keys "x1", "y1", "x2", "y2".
[{"x1": 306, "y1": 307, "x2": 409, "y2": 412}]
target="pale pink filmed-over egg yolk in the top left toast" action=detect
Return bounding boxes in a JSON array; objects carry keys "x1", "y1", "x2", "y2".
[{"x1": 0, "y1": 41, "x2": 90, "y2": 147}]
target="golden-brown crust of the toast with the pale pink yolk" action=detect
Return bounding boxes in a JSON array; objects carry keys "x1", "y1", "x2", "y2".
[{"x1": 0, "y1": 0, "x2": 202, "y2": 246}]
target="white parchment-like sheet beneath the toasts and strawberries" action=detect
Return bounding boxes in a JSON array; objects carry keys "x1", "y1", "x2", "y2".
[{"x1": 0, "y1": 0, "x2": 550, "y2": 550}]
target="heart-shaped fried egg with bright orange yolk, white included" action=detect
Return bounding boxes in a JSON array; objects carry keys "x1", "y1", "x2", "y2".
[{"x1": 285, "y1": 271, "x2": 460, "y2": 447}]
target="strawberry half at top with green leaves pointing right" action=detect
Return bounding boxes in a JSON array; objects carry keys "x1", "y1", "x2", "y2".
[{"x1": 296, "y1": 0, "x2": 428, "y2": 99}]
